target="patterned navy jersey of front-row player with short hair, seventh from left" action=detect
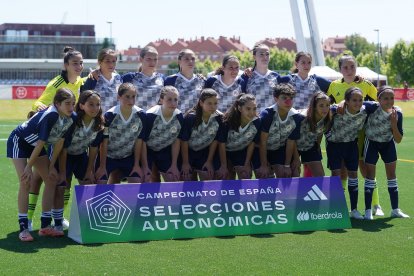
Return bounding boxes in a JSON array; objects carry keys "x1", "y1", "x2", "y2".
[{"x1": 260, "y1": 104, "x2": 304, "y2": 150}]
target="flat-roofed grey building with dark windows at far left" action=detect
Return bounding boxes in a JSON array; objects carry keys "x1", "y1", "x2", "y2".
[{"x1": 0, "y1": 23, "x2": 115, "y2": 59}]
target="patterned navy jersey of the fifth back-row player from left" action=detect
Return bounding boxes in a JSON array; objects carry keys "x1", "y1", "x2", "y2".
[{"x1": 205, "y1": 75, "x2": 245, "y2": 112}]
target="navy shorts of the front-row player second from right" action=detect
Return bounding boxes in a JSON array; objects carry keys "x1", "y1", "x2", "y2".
[{"x1": 326, "y1": 140, "x2": 359, "y2": 171}]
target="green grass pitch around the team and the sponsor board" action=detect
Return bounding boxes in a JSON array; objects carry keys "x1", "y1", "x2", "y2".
[{"x1": 0, "y1": 101, "x2": 414, "y2": 275}]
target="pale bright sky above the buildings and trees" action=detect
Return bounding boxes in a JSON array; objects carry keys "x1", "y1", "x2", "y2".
[{"x1": 0, "y1": 0, "x2": 414, "y2": 49}]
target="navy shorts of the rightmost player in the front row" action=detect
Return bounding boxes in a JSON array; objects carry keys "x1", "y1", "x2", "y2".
[{"x1": 364, "y1": 139, "x2": 397, "y2": 165}]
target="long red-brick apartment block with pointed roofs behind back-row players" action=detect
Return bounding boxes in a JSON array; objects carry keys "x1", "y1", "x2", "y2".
[{"x1": 121, "y1": 36, "x2": 249, "y2": 69}]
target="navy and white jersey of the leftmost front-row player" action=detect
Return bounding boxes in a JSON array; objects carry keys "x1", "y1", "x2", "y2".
[{"x1": 16, "y1": 105, "x2": 75, "y2": 146}]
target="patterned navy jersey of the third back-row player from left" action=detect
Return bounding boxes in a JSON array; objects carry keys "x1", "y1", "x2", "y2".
[{"x1": 122, "y1": 72, "x2": 164, "y2": 110}]
